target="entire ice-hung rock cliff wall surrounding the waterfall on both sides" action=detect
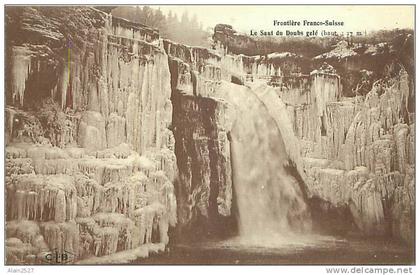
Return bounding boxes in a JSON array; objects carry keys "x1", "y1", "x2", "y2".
[{"x1": 6, "y1": 7, "x2": 415, "y2": 263}]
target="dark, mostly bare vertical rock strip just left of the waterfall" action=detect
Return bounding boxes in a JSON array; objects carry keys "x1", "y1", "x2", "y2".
[{"x1": 164, "y1": 40, "x2": 234, "y2": 239}]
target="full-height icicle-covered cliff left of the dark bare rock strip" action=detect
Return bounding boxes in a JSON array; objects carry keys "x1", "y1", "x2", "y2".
[{"x1": 6, "y1": 7, "x2": 176, "y2": 263}]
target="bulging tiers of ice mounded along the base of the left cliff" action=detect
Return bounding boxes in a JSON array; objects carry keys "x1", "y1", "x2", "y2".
[{"x1": 6, "y1": 144, "x2": 176, "y2": 261}]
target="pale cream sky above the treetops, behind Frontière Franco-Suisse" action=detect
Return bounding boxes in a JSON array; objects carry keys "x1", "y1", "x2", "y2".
[{"x1": 154, "y1": 5, "x2": 414, "y2": 33}]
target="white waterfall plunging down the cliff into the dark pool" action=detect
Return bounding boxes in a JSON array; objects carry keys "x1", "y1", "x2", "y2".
[{"x1": 218, "y1": 82, "x2": 311, "y2": 245}]
